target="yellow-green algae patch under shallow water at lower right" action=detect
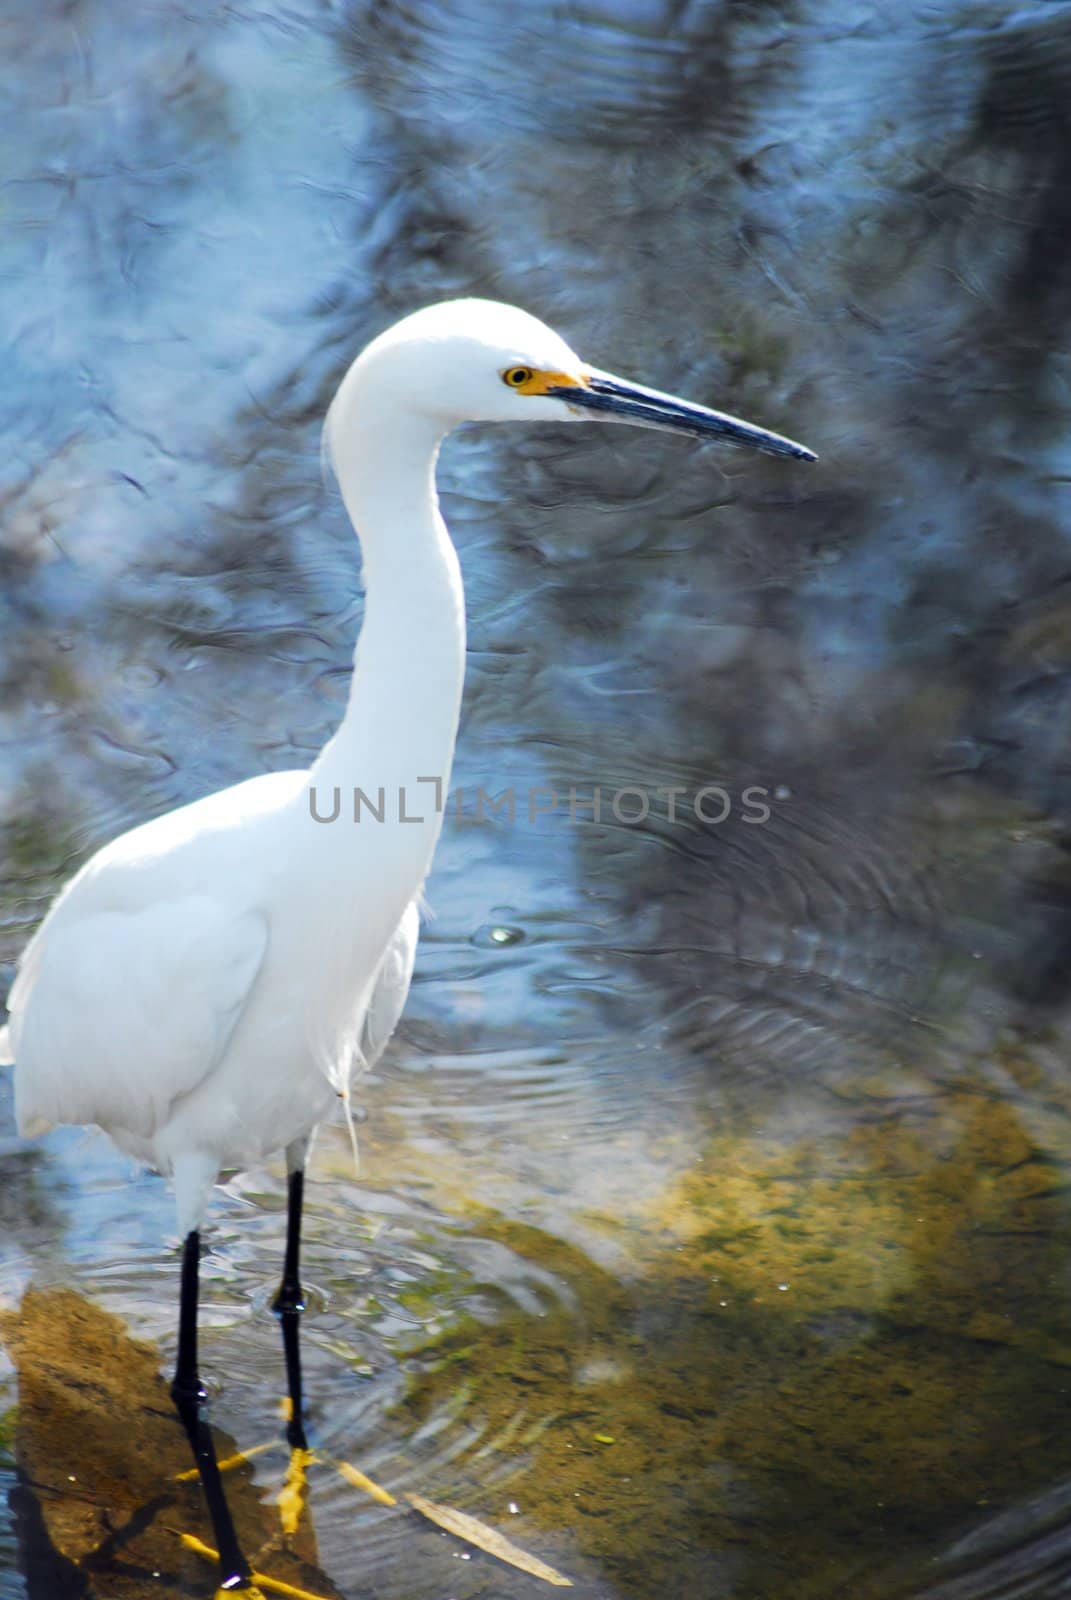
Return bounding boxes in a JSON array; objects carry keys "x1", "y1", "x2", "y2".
[{"x1": 382, "y1": 1053, "x2": 1071, "y2": 1597}]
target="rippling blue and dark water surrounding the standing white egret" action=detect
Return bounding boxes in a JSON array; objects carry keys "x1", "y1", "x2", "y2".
[{"x1": 0, "y1": 0, "x2": 1071, "y2": 1600}]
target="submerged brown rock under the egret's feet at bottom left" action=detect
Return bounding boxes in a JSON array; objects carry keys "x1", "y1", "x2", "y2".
[{"x1": 0, "y1": 1288, "x2": 339, "y2": 1600}]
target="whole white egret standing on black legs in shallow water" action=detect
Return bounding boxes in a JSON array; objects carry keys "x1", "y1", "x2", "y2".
[{"x1": 0, "y1": 299, "x2": 815, "y2": 1594}]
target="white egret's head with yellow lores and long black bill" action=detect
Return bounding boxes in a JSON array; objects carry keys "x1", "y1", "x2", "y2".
[{"x1": 331, "y1": 299, "x2": 815, "y2": 461}]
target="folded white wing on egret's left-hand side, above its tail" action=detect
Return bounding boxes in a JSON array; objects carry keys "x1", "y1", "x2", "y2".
[{"x1": 8, "y1": 885, "x2": 267, "y2": 1141}]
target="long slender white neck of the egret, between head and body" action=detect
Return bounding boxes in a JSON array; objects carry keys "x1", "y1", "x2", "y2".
[{"x1": 311, "y1": 398, "x2": 464, "y2": 832}]
